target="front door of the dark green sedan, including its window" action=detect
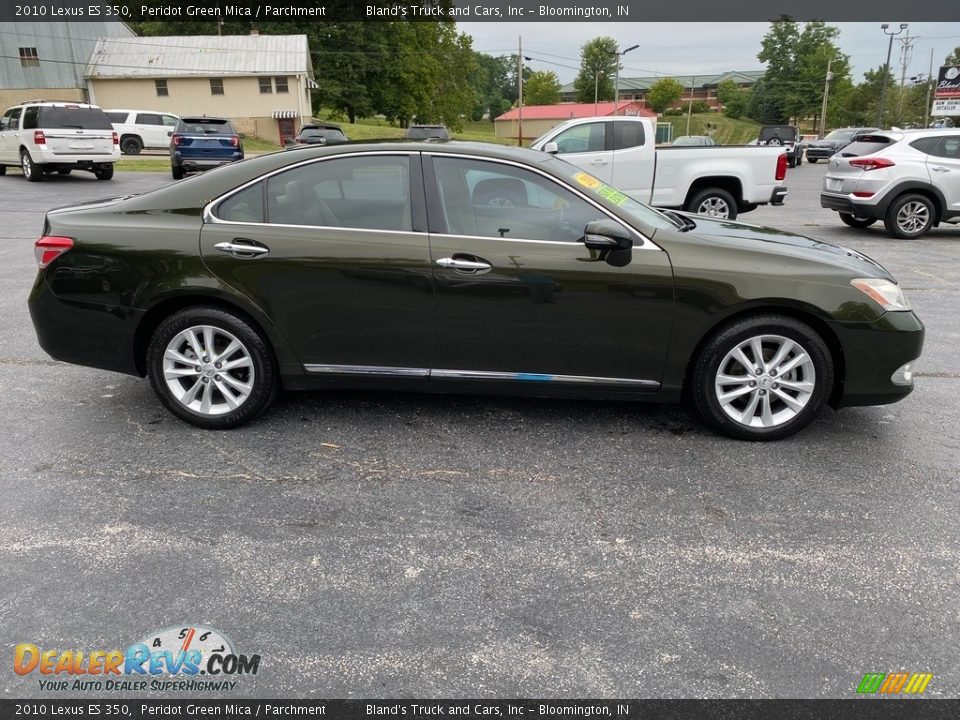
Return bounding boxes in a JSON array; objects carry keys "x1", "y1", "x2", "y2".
[{"x1": 424, "y1": 151, "x2": 673, "y2": 392}]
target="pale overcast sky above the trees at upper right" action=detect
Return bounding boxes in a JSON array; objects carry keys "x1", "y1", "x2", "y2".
[{"x1": 457, "y1": 20, "x2": 960, "y2": 84}]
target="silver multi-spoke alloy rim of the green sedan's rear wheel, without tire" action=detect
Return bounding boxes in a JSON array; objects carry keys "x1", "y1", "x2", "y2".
[{"x1": 163, "y1": 325, "x2": 256, "y2": 416}]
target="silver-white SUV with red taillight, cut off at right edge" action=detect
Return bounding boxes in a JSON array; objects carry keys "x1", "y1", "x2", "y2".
[{"x1": 820, "y1": 129, "x2": 960, "y2": 239}]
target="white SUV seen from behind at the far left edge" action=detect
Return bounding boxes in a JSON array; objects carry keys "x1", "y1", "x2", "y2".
[{"x1": 0, "y1": 100, "x2": 120, "y2": 182}]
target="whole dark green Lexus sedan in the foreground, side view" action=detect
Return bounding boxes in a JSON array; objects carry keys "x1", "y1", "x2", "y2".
[{"x1": 29, "y1": 143, "x2": 924, "y2": 440}]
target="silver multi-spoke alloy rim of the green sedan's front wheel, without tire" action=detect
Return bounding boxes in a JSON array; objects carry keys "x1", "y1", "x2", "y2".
[{"x1": 714, "y1": 335, "x2": 817, "y2": 428}]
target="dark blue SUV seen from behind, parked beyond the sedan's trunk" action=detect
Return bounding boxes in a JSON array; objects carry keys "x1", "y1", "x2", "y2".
[{"x1": 170, "y1": 116, "x2": 243, "y2": 180}]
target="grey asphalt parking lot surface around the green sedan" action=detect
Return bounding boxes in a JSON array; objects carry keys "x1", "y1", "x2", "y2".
[{"x1": 0, "y1": 163, "x2": 960, "y2": 698}]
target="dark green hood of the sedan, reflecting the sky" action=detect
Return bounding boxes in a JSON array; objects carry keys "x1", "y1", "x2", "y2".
[{"x1": 668, "y1": 213, "x2": 893, "y2": 280}]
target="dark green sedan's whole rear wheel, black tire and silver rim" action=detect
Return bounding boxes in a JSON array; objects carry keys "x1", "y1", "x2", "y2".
[{"x1": 146, "y1": 306, "x2": 279, "y2": 430}]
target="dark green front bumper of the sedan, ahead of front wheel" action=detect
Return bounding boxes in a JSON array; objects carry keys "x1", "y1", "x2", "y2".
[{"x1": 833, "y1": 311, "x2": 924, "y2": 408}]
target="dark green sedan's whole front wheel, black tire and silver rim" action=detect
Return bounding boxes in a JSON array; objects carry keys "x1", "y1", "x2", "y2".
[{"x1": 691, "y1": 314, "x2": 834, "y2": 440}]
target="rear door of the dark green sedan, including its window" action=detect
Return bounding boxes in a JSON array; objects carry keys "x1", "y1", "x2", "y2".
[{"x1": 200, "y1": 152, "x2": 433, "y2": 380}]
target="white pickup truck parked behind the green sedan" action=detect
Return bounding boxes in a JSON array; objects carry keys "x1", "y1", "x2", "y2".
[{"x1": 530, "y1": 116, "x2": 787, "y2": 220}]
